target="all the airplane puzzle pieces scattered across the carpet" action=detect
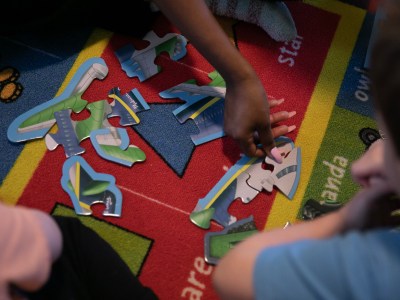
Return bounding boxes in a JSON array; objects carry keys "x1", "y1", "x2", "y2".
[{"x1": 7, "y1": 31, "x2": 301, "y2": 264}]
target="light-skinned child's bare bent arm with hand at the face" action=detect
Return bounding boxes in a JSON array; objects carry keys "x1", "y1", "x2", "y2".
[{"x1": 213, "y1": 182, "x2": 399, "y2": 299}]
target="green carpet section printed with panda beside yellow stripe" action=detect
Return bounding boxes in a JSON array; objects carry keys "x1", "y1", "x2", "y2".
[{"x1": 299, "y1": 106, "x2": 377, "y2": 213}]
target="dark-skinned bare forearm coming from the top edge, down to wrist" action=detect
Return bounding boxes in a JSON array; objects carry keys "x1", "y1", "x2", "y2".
[{"x1": 154, "y1": 0, "x2": 256, "y2": 85}]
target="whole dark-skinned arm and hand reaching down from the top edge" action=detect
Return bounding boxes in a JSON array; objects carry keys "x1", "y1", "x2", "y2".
[{"x1": 154, "y1": 0, "x2": 275, "y2": 156}]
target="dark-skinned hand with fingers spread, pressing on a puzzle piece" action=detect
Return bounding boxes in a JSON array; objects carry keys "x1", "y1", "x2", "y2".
[{"x1": 224, "y1": 78, "x2": 295, "y2": 158}]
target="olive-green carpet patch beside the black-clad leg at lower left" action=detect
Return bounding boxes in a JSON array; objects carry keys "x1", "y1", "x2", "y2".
[{"x1": 52, "y1": 204, "x2": 153, "y2": 275}]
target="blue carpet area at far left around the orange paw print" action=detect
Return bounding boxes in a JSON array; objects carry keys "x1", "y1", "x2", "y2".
[{"x1": 0, "y1": 29, "x2": 90, "y2": 184}]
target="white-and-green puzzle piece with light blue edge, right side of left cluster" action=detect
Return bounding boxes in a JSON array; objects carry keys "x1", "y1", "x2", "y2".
[{"x1": 90, "y1": 127, "x2": 146, "y2": 167}]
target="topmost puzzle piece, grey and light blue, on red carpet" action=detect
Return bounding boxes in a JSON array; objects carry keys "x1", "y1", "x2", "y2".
[{"x1": 115, "y1": 31, "x2": 187, "y2": 82}]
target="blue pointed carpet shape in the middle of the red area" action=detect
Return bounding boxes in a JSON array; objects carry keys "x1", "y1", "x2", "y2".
[{"x1": 132, "y1": 104, "x2": 199, "y2": 177}]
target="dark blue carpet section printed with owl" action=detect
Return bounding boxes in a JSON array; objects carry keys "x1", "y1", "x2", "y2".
[{"x1": 336, "y1": 13, "x2": 374, "y2": 118}]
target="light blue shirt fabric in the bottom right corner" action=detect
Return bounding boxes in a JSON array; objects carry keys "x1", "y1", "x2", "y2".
[{"x1": 253, "y1": 230, "x2": 400, "y2": 300}]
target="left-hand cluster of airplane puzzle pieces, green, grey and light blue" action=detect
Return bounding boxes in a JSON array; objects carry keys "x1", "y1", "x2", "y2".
[{"x1": 7, "y1": 58, "x2": 150, "y2": 216}]
